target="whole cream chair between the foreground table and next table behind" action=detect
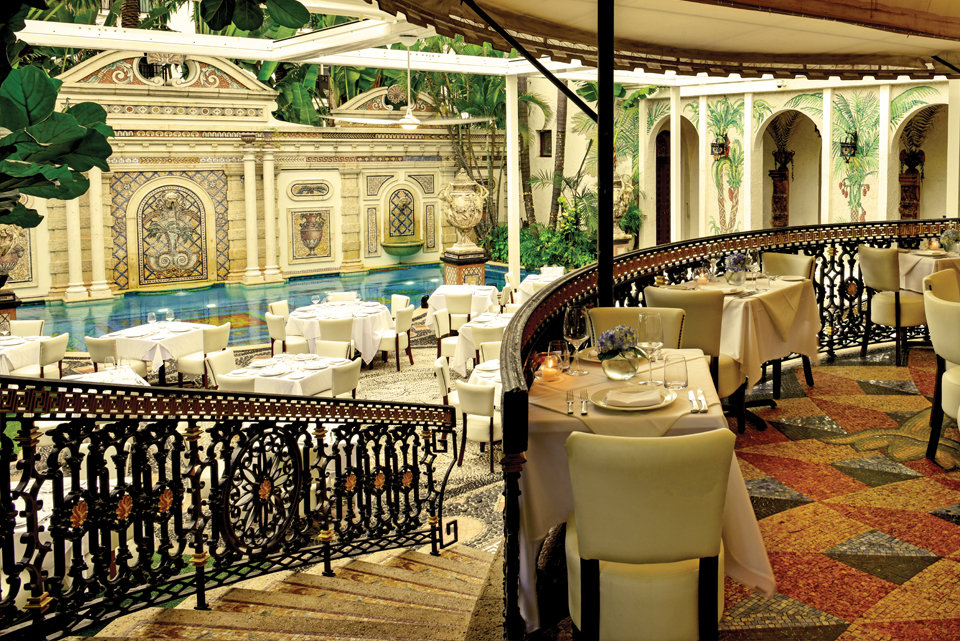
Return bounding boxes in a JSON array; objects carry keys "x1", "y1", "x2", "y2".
[{"x1": 643, "y1": 287, "x2": 756, "y2": 433}]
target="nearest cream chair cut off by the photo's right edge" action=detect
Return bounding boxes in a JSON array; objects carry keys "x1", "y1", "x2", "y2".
[{"x1": 923, "y1": 288, "x2": 960, "y2": 461}]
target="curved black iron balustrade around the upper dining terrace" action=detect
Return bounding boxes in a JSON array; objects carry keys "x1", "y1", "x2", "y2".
[{"x1": 501, "y1": 219, "x2": 958, "y2": 639}]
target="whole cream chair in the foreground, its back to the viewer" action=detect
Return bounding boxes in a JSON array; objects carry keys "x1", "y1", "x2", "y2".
[{"x1": 564, "y1": 429, "x2": 736, "y2": 641}]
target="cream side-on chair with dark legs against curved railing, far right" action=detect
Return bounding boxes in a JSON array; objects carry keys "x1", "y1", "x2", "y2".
[{"x1": 857, "y1": 245, "x2": 927, "y2": 367}]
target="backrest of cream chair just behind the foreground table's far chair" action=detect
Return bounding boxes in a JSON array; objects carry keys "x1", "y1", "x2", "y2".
[{"x1": 643, "y1": 287, "x2": 723, "y2": 357}]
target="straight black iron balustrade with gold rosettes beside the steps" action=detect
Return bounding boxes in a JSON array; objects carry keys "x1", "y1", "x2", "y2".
[{"x1": 0, "y1": 377, "x2": 457, "y2": 639}]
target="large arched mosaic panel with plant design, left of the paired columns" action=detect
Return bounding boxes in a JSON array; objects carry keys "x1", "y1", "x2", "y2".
[{"x1": 136, "y1": 185, "x2": 207, "y2": 285}]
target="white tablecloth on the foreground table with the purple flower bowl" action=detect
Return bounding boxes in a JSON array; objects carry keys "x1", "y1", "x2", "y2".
[{"x1": 520, "y1": 350, "x2": 776, "y2": 631}]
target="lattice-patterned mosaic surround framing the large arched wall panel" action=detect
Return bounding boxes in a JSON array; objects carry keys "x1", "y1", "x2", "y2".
[{"x1": 110, "y1": 170, "x2": 230, "y2": 290}]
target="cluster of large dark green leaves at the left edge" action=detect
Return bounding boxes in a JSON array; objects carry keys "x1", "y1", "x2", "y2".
[{"x1": 0, "y1": 67, "x2": 113, "y2": 227}]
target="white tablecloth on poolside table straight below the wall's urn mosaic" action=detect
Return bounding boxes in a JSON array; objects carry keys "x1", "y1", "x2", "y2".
[{"x1": 286, "y1": 303, "x2": 394, "y2": 363}]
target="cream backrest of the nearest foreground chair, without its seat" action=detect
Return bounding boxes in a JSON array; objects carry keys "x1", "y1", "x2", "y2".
[{"x1": 568, "y1": 428, "x2": 737, "y2": 564}]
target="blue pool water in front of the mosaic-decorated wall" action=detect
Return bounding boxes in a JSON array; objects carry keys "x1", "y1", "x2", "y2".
[{"x1": 17, "y1": 264, "x2": 506, "y2": 352}]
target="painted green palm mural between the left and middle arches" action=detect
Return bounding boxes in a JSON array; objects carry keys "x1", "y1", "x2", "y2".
[{"x1": 707, "y1": 96, "x2": 744, "y2": 234}]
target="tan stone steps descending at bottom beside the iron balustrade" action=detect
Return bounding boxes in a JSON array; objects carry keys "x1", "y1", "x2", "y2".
[{"x1": 75, "y1": 544, "x2": 503, "y2": 641}]
